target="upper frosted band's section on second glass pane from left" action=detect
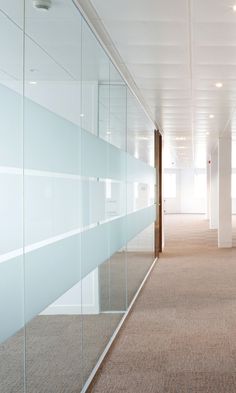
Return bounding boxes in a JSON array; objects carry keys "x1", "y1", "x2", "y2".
[{"x1": 25, "y1": 100, "x2": 80, "y2": 174}]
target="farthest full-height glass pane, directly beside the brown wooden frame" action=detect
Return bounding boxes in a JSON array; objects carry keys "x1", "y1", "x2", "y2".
[{"x1": 126, "y1": 90, "x2": 155, "y2": 305}]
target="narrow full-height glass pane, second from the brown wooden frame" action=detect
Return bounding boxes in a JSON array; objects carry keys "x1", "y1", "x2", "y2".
[{"x1": 107, "y1": 63, "x2": 127, "y2": 324}]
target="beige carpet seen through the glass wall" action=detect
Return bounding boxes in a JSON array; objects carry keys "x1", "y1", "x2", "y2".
[{"x1": 0, "y1": 252, "x2": 154, "y2": 393}]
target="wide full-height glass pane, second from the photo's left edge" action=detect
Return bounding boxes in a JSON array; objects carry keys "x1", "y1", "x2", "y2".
[{"x1": 24, "y1": 1, "x2": 83, "y2": 393}]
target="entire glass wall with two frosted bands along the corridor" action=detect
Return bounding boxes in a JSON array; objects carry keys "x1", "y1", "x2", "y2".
[{"x1": 0, "y1": 0, "x2": 155, "y2": 393}]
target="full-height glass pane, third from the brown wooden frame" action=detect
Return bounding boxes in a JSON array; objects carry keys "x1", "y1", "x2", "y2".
[{"x1": 82, "y1": 16, "x2": 111, "y2": 380}]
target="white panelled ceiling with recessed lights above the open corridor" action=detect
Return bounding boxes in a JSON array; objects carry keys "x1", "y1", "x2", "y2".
[{"x1": 85, "y1": 0, "x2": 236, "y2": 165}]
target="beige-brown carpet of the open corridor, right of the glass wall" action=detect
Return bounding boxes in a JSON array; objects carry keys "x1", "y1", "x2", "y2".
[{"x1": 90, "y1": 215, "x2": 236, "y2": 393}]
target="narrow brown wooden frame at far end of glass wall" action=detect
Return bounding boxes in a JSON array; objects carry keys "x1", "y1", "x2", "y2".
[{"x1": 154, "y1": 130, "x2": 163, "y2": 258}]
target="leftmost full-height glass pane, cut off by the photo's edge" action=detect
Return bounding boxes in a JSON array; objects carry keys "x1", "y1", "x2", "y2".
[{"x1": 0, "y1": 0, "x2": 25, "y2": 393}]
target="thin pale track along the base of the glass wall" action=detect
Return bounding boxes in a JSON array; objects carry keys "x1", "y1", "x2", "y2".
[{"x1": 81, "y1": 258, "x2": 158, "y2": 393}]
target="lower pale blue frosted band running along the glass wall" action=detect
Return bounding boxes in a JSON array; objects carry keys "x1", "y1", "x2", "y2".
[{"x1": 0, "y1": 206, "x2": 155, "y2": 342}]
